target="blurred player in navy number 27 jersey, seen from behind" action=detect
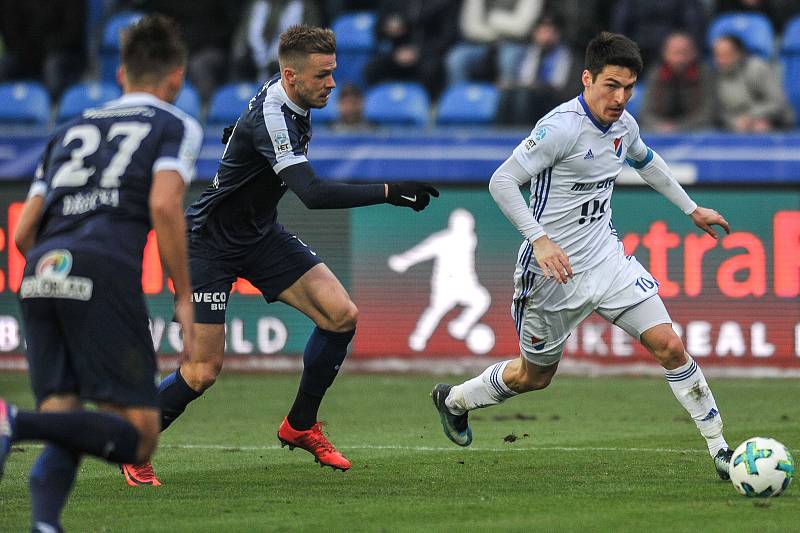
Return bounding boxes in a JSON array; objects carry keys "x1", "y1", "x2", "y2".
[{"x1": 0, "y1": 12, "x2": 202, "y2": 531}]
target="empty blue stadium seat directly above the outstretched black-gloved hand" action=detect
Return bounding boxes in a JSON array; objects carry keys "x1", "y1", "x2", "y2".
[{"x1": 364, "y1": 82, "x2": 430, "y2": 126}]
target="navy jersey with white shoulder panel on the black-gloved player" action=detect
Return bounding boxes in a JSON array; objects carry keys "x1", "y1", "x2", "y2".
[{"x1": 186, "y1": 75, "x2": 311, "y2": 248}]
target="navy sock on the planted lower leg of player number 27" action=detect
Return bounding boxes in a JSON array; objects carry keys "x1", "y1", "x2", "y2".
[{"x1": 29, "y1": 444, "x2": 80, "y2": 531}]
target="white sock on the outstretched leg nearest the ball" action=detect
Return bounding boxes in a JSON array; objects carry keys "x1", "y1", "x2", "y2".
[{"x1": 664, "y1": 356, "x2": 728, "y2": 457}]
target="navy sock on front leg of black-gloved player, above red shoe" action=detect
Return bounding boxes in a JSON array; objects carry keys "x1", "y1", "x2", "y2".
[{"x1": 287, "y1": 328, "x2": 355, "y2": 430}]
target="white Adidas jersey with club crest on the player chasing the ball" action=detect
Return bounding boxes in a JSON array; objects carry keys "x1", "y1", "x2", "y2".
[{"x1": 514, "y1": 96, "x2": 652, "y2": 274}]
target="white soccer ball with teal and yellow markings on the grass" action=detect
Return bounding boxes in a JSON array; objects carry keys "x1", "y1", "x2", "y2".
[{"x1": 730, "y1": 437, "x2": 794, "y2": 498}]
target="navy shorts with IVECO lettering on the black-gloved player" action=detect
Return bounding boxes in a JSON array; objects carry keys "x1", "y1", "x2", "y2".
[{"x1": 189, "y1": 225, "x2": 322, "y2": 324}]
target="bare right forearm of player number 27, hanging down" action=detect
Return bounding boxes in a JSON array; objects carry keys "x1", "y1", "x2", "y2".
[{"x1": 149, "y1": 170, "x2": 194, "y2": 359}]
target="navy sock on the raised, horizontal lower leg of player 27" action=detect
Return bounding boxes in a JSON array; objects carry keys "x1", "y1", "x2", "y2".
[{"x1": 14, "y1": 411, "x2": 139, "y2": 463}]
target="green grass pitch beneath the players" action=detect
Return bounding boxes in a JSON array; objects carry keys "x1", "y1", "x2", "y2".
[{"x1": 0, "y1": 373, "x2": 800, "y2": 533}]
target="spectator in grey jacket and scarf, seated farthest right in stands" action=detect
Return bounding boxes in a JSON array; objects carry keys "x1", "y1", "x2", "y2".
[{"x1": 714, "y1": 35, "x2": 794, "y2": 133}]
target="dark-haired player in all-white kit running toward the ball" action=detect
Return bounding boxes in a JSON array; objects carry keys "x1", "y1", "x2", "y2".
[{"x1": 431, "y1": 32, "x2": 732, "y2": 479}]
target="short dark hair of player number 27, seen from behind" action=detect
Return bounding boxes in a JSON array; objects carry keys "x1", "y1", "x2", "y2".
[{"x1": 120, "y1": 15, "x2": 188, "y2": 83}]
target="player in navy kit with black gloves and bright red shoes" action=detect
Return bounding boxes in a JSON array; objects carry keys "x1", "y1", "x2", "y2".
[{"x1": 126, "y1": 22, "x2": 439, "y2": 472}]
